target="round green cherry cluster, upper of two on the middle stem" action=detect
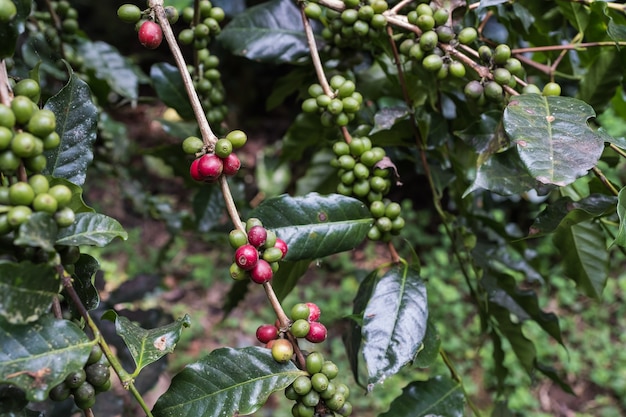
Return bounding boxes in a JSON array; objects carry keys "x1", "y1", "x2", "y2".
[{"x1": 302, "y1": 75, "x2": 363, "y2": 127}]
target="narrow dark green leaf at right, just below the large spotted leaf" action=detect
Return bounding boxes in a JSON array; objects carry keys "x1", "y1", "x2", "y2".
[{"x1": 528, "y1": 194, "x2": 617, "y2": 237}]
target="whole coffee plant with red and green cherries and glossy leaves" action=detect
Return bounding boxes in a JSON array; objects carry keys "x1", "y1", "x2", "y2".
[{"x1": 0, "y1": 0, "x2": 626, "y2": 417}]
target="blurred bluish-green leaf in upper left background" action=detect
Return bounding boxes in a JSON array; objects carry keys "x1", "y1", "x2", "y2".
[{"x1": 78, "y1": 41, "x2": 140, "y2": 100}]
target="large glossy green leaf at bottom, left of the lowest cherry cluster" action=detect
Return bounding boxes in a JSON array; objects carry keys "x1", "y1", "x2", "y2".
[{"x1": 152, "y1": 347, "x2": 306, "y2": 417}]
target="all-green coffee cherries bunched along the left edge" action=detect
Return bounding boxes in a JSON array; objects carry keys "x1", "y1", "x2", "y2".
[{"x1": 0, "y1": 79, "x2": 75, "y2": 234}]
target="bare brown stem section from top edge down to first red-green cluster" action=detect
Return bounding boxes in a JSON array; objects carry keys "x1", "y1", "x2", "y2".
[{"x1": 148, "y1": 0, "x2": 217, "y2": 150}]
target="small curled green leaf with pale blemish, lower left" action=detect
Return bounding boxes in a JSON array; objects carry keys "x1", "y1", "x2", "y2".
[{"x1": 102, "y1": 310, "x2": 191, "y2": 377}]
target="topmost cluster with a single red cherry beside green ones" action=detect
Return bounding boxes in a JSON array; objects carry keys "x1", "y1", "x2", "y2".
[{"x1": 117, "y1": 3, "x2": 178, "y2": 49}]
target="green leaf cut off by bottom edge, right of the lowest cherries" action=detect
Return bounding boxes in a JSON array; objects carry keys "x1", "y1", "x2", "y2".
[{"x1": 380, "y1": 376, "x2": 465, "y2": 417}]
